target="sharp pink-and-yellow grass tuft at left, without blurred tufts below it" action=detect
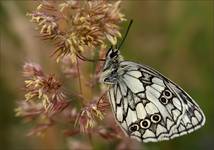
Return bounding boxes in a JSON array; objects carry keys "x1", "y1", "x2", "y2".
[{"x1": 23, "y1": 63, "x2": 68, "y2": 114}]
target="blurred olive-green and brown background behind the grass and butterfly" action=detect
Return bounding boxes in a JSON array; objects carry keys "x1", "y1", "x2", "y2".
[{"x1": 0, "y1": 0, "x2": 214, "y2": 150}]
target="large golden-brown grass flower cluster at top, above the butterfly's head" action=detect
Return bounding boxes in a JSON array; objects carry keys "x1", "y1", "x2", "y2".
[{"x1": 27, "y1": 0, "x2": 125, "y2": 62}]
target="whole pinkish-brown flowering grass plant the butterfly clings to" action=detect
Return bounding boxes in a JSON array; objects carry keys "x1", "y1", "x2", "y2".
[{"x1": 15, "y1": 0, "x2": 140, "y2": 149}]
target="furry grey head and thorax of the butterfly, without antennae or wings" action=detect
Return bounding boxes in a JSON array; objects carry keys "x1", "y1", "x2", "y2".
[{"x1": 100, "y1": 48, "x2": 123, "y2": 84}]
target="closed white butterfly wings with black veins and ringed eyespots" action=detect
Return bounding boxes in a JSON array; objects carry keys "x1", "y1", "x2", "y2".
[{"x1": 109, "y1": 61, "x2": 205, "y2": 142}]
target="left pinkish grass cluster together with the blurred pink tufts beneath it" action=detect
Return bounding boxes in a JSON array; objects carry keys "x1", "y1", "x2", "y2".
[{"x1": 15, "y1": 63, "x2": 69, "y2": 136}]
